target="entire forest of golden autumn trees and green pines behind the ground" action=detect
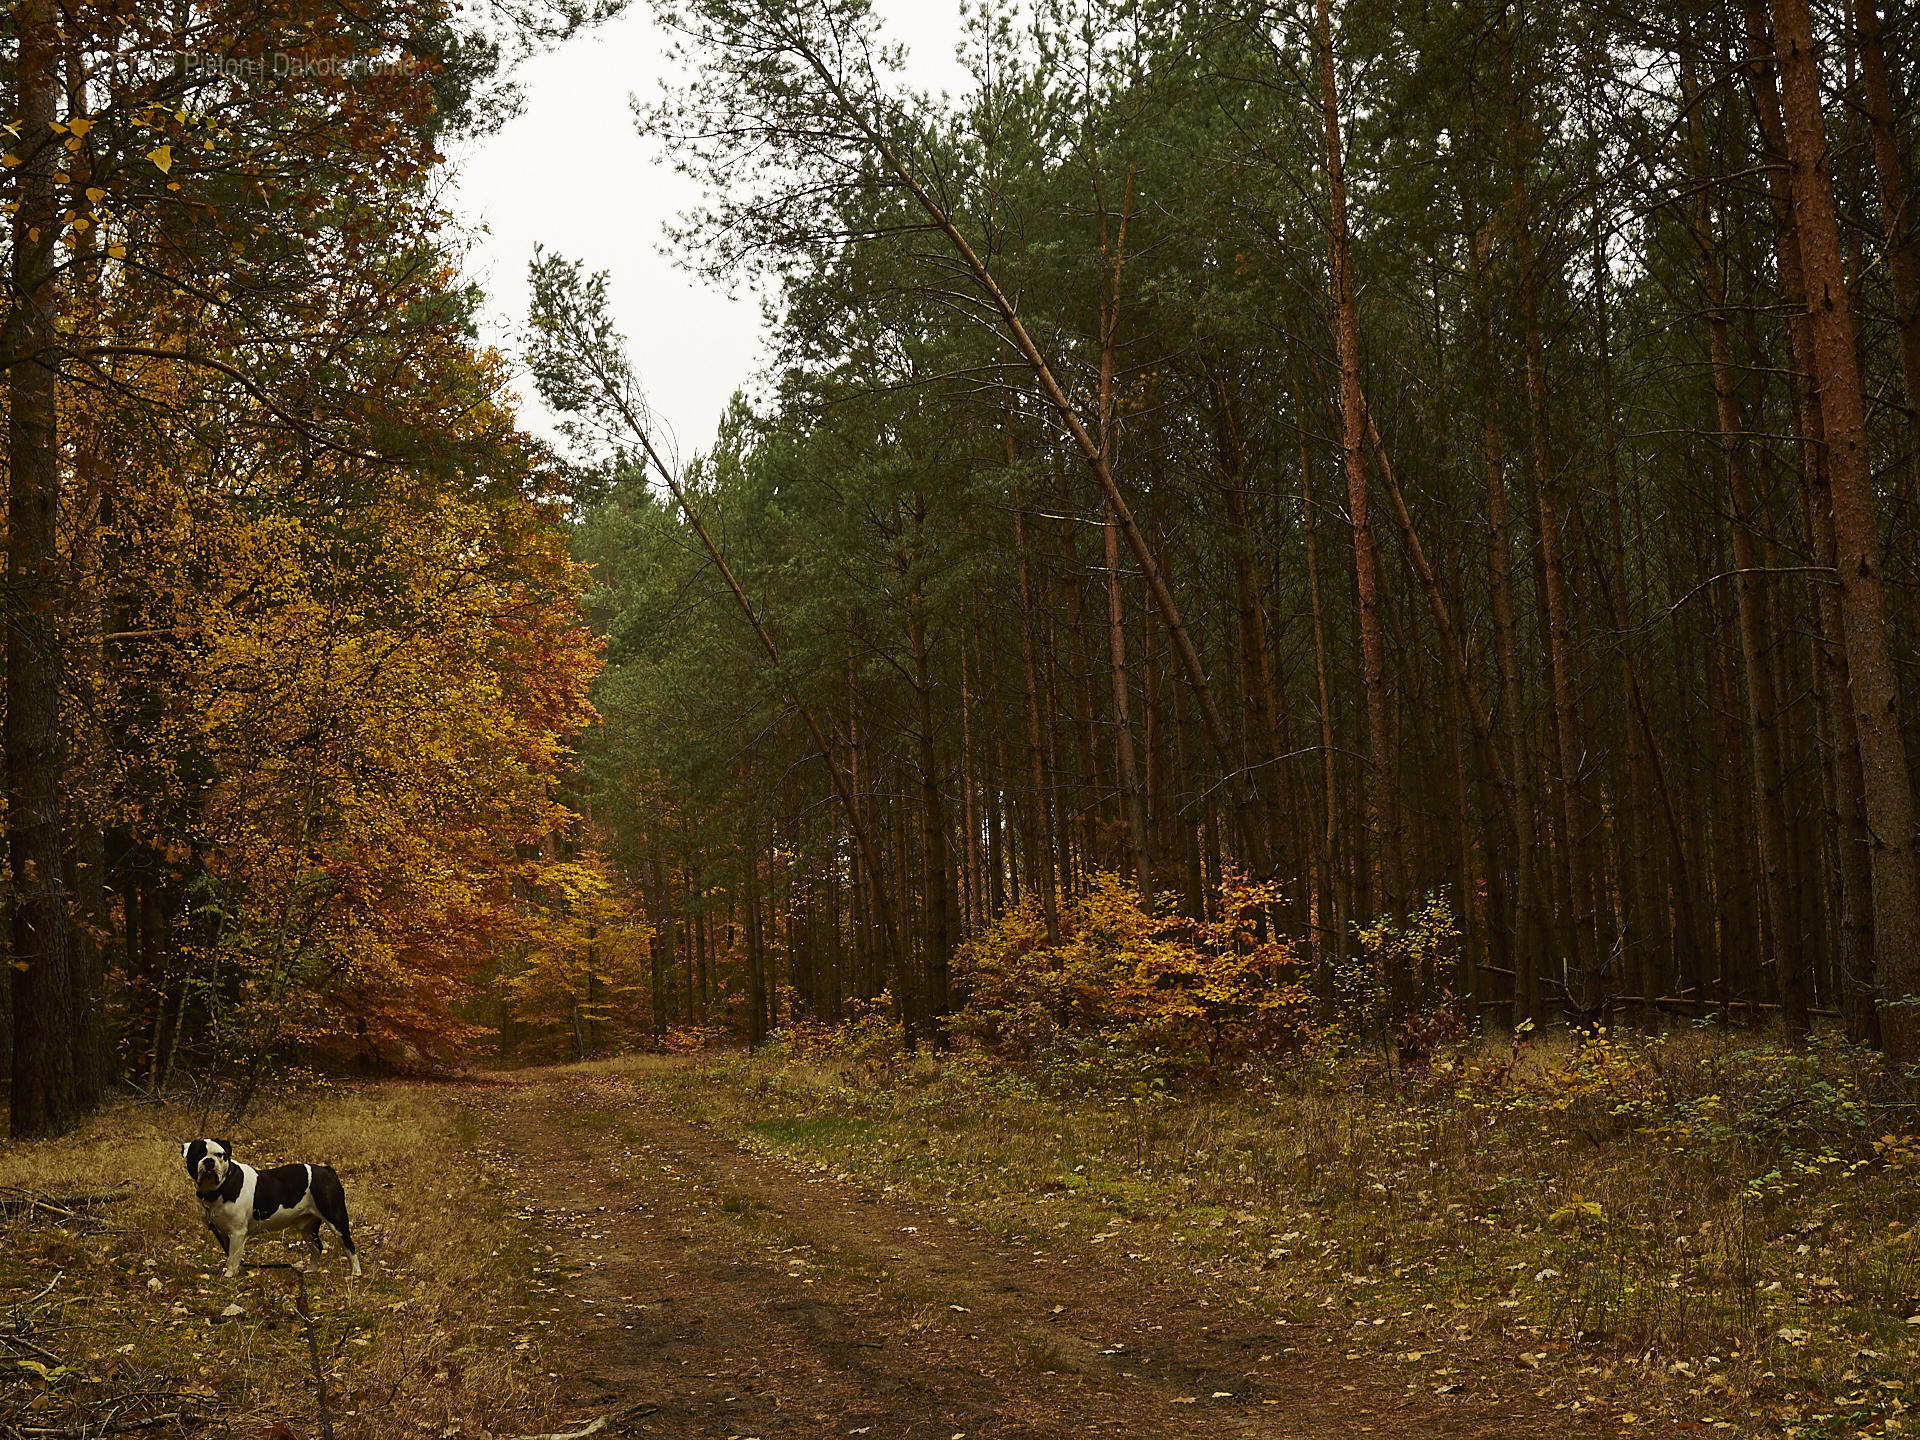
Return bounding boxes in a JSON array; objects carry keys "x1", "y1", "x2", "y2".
[{"x1": 0, "y1": 0, "x2": 1920, "y2": 1135}]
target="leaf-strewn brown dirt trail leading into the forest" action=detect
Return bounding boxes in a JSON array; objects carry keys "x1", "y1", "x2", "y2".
[{"x1": 456, "y1": 1071, "x2": 1592, "y2": 1440}]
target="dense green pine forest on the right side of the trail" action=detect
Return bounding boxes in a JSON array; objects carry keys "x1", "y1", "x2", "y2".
[{"x1": 560, "y1": 0, "x2": 1920, "y2": 1064}]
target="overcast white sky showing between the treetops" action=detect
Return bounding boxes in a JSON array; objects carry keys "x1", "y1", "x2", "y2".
[{"x1": 451, "y1": 0, "x2": 966, "y2": 457}]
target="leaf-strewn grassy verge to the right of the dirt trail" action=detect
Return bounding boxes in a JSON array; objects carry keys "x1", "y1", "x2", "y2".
[{"x1": 636, "y1": 1021, "x2": 1920, "y2": 1440}]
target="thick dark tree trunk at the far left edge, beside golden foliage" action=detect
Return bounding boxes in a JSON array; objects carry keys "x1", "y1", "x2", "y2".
[{"x1": 4, "y1": 0, "x2": 83, "y2": 1139}]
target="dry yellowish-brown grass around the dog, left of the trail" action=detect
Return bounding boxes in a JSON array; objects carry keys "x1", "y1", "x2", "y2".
[{"x1": 0, "y1": 1087, "x2": 561, "y2": 1440}]
